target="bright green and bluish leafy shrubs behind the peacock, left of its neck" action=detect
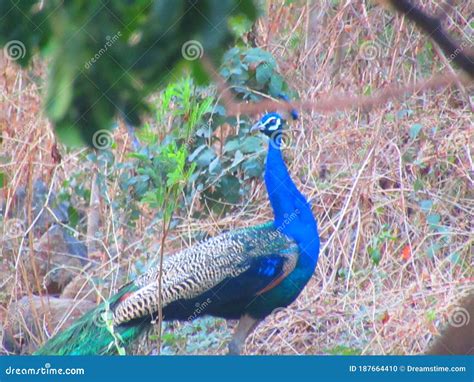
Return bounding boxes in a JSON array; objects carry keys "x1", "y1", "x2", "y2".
[{"x1": 53, "y1": 48, "x2": 285, "y2": 233}]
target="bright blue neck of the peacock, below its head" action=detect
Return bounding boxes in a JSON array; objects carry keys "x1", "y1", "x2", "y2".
[{"x1": 265, "y1": 140, "x2": 319, "y2": 264}]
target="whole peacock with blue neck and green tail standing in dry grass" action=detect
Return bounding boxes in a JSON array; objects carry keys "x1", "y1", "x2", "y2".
[{"x1": 35, "y1": 112, "x2": 319, "y2": 355}]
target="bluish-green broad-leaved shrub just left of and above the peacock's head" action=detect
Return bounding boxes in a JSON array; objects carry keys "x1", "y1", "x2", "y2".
[{"x1": 183, "y1": 47, "x2": 294, "y2": 213}]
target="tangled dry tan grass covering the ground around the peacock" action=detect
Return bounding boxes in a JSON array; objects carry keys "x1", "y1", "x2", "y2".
[{"x1": 0, "y1": 1, "x2": 474, "y2": 354}]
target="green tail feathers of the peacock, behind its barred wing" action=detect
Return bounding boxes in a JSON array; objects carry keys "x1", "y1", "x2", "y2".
[{"x1": 33, "y1": 283, "x2": 150, "y2": 355}]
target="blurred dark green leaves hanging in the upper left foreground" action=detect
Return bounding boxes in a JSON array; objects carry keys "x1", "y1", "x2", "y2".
[{"x1": 0, "y1": 0, "x2": 257, "y2": 144}]
